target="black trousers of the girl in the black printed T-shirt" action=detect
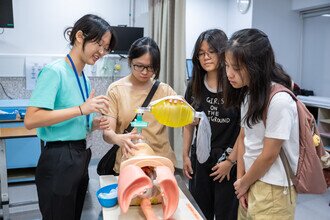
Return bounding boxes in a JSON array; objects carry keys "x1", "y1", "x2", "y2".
[{"x1": 189, "y1": 145, "x2": 238, "y2": 220}]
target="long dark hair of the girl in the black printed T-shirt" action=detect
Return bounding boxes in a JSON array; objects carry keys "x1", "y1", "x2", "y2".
[{"x1": 190, "y1": 29, "x2": 228, "y2": 108}]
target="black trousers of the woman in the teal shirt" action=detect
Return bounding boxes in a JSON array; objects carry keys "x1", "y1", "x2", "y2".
[{"x1": 36, "y1": 140, "x2": 91, "y2": 220}]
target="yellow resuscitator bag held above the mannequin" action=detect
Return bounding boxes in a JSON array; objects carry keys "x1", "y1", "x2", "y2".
[{"x1": 138, "y1": 96, "x2": 199, "y2": 128}]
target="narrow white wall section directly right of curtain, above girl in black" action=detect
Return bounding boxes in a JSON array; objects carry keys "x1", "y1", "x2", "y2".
[{"x1": 186, "y1": 0, "x2": 227, "y2": 58}]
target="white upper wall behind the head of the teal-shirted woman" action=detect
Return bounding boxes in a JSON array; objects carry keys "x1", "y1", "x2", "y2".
[{"x1": 0, "y1": 0, "x2": 147, "y2": 54}]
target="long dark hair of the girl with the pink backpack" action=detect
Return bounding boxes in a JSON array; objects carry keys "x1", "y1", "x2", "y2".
[{"x1": 224, "y1": 29, "x2": 291, "y2": 127}]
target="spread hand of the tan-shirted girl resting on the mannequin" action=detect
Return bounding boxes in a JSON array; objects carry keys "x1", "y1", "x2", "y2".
[{"x1": 116, "y1": 130, "x2": 143, "y2": 158}]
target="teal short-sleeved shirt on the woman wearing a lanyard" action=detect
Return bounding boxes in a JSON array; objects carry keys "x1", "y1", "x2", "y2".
[{"x1": 28, "y1": 59, "x2": 93, "y2": 141}]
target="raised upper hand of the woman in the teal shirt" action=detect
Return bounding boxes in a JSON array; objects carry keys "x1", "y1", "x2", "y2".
[{"x1": 80, "y1": 89, "x2": 110, "y2": 115}]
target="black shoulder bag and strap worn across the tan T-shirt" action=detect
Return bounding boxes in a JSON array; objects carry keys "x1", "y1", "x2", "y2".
[{"x1": 97, "y1": 80, "x2": 160, "y2": 176}]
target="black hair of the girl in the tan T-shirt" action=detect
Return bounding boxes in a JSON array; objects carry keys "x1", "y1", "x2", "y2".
[{"x1": 128, "y1": 37, "x2": 160, "y2": 79}]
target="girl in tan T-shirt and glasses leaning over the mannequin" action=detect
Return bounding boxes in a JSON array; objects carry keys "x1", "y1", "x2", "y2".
[{"x1": 103, "y1": 37, "x2": 176, "y2": 173}]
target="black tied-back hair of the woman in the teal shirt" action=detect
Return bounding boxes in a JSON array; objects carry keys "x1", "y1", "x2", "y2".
[{"x1": 64, "y1": 14, "x2": 117, "y2": 52}]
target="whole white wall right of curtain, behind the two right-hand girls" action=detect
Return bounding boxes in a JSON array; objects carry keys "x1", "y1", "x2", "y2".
[{"x1": 186, "y1": 0, "x2": 302, "y2": 84}]
